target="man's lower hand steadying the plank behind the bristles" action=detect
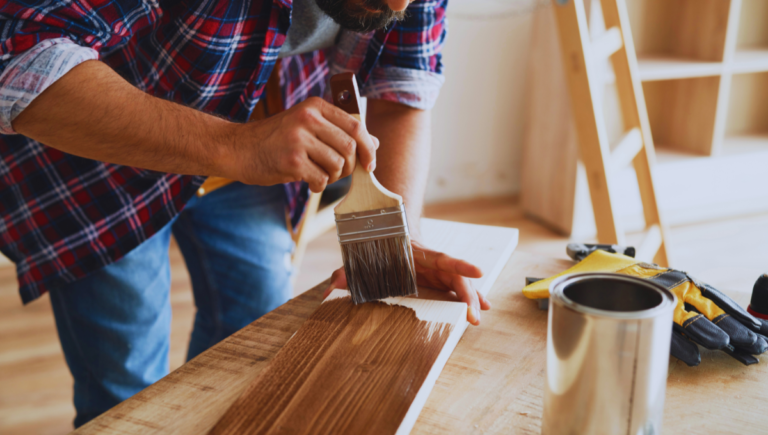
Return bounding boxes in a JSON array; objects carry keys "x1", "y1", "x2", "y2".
[{"x1": 323, "y1": 240, "x2": 491, "y2": 325}]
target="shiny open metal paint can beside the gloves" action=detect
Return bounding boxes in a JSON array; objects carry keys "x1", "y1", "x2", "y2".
[{"x1": 542, "y1": 273, "x2": 677, "y2": 435}]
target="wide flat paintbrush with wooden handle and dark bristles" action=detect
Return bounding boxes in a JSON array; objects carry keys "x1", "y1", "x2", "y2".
[{"x1": 331, "y1": 73, "x2": 417, "y2": 304}]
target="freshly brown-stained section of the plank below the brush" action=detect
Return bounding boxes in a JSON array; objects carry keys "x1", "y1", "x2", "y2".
[{"x1": 211, "y1": 296, "x2": 466, "y2": 435}]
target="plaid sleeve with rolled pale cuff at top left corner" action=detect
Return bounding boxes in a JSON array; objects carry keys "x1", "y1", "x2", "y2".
[{"x1": 0, "y1": 0, "x2": 143, "y2": 134}]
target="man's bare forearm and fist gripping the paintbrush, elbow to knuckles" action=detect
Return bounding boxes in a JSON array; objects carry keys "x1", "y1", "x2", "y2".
[{"x1": 13, "y1": 60, "x2": 378, "y2": 192}]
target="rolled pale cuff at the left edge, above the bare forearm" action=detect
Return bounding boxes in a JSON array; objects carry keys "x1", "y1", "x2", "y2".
[{"x1": 0, "y1": 38, "x2": 99, "y2": 134}]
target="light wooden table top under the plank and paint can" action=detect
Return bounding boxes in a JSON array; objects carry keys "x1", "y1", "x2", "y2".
[{"x1": 75, "y1": 252, "x2": 768, "y2": 434}]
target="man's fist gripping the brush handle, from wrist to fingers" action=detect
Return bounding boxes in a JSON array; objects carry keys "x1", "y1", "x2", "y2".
[{"x1": 220, "y1": 97, "x2": 379, "y2": 192}]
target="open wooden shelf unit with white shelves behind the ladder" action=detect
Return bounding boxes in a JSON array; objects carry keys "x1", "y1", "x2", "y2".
[{"x1": 521, "y1": 0, "x2": 768, "y2": 245}]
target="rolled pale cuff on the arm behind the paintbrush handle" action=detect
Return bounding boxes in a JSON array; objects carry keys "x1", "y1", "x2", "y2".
[{"x1": 362, "y1": 66, "x2": 445, "y2": 110}]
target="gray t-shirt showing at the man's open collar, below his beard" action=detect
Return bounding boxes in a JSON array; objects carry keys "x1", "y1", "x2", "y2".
[{"x1": 277, "y1": 0, "x2": 341, "y2": 58}]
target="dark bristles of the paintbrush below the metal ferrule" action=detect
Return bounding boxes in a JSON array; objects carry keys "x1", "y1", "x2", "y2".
[{"x1": 341, "y1": 236, "x2": 417, "y2": 304}]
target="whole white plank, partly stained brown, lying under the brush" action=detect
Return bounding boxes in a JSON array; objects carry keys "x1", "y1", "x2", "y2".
[{"x1": 211, "y1": 220, "x2": 517, "y2": 435}]
